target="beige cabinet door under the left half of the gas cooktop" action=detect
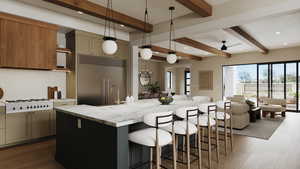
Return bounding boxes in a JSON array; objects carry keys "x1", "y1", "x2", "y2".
[{"x1": 5, "y1": 113, "x2": 31, "y2": 144}]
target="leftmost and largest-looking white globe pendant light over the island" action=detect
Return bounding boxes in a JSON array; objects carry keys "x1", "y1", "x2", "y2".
[{"x1": 102, "y1": 0, "x2": 118, "y2": 55}]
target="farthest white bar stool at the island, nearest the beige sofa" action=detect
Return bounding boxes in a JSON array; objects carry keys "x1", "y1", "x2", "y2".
[{"x1": 214, "y1": 101, "x2": 233, "y2": 155}]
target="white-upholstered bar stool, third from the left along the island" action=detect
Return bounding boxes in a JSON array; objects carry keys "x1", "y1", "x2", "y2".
[{"x1": 190, "y1": 104, "x2": 219, "y2": 168}]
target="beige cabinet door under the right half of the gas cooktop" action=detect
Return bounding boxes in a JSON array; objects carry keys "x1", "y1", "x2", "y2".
[{"x1": 31, "y1": 111, "x2": 50, "y2": 139}]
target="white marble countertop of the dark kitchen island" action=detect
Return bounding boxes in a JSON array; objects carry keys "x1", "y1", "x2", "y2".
[{"x1": 56, "y1": 100, "x2": 214, "y2": 127}]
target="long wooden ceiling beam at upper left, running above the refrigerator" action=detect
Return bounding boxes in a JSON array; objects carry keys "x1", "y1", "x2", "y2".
[{"x1": 43, "y1": 0, "x2": 153, "y2": 33}]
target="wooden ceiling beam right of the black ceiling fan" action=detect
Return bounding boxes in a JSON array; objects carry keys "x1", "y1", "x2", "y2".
[{"x1": 225, "y1": 26, "x2": 269, "y2": 54}]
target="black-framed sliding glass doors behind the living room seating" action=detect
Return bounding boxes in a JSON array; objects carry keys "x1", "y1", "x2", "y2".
[{"x1": 223, "y1": 61, "x2": 300, "y2": 112}]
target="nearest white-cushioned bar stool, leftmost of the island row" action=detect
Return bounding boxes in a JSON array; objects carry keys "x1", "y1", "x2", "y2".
[{"x1": 128, "y1": 111, "x2": 176, "y2": 169}]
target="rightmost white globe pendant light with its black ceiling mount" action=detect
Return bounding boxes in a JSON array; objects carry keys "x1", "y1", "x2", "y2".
[{"x1": 167, "y1": 6, "x2": 177, "y2": 64}]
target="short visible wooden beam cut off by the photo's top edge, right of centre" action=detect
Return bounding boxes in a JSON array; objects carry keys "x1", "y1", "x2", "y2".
[{"x1": 176, "y1": 0, "x2": 212, "y2": 17}]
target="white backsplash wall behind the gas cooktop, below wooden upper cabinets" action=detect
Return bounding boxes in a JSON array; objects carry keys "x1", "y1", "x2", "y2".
[{"x1": 0, "y1": 69, "x2": 66, "y2": 101}]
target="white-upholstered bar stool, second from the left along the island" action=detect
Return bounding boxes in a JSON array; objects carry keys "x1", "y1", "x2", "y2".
[{"x1": 162, "y1": 107, "x2": 201, "y2": 169}]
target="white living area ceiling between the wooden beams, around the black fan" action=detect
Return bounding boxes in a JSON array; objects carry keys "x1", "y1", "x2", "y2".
[{"x1": 155, "y1": 12, "x2": 300, "y2": 57}]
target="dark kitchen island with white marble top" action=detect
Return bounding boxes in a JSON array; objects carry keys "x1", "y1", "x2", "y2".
[{"x1": 55, "y1": 100, "x2": 209, "y2": 169}]
